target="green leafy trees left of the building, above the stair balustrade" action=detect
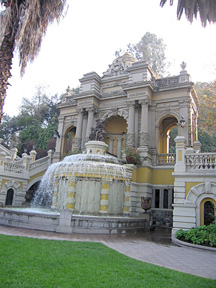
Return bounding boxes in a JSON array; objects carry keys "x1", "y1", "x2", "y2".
[{"x1": 0, "y1": 87, "x2": 59, "y2": 158}]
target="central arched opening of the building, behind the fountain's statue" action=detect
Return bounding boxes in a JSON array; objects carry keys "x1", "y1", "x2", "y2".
[{"x1": 104, "y1": 116, "x2": 127, "y2": 158}]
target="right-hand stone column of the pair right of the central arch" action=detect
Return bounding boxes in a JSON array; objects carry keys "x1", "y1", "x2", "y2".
[{"x1": 139, "y1": 99, "x2": 149, "y2": 147}]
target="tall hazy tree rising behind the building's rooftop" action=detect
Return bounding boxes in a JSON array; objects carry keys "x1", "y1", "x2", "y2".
[{"x1": 115, "y1": 32, "x2": 169, "y2": 76}]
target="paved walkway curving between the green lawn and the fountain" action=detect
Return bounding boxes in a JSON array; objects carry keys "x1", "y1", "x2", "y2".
[{"x1": 0, "y1": 225, "x2": 216, "y2": 279}]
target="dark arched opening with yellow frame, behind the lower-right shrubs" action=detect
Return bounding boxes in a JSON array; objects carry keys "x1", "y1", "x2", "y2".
[{"x1": 200, "y1": 198, "x2": 216, "y2": 226}]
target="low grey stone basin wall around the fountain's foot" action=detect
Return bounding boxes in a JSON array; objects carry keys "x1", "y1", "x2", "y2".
[{"x1": 0, "y1": 208, "x2": 148, "y2": 234}]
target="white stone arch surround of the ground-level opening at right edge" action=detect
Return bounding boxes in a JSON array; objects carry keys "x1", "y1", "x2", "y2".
[{"x1": 185, "y1": 182, "x2": 216, "y2": 226}]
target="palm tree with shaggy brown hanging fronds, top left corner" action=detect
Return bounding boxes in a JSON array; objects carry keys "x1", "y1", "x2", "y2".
[{"x1": 0, "y1": 0, "x2": 66, "y2": 122}]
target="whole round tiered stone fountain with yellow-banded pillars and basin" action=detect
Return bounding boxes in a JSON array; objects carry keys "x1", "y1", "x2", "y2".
[{"x1": 0, "y1": 140, "x2": 147, "y2": 234}]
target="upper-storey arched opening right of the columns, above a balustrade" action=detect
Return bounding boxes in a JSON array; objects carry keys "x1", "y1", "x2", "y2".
[{"x1": 159, "y1": 116, "x2": 178, "y2": 153}]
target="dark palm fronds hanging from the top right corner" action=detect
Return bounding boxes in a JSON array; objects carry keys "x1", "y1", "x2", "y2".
[{"x1": 160, "y1": 0, "x2": 216, "y2": 27}]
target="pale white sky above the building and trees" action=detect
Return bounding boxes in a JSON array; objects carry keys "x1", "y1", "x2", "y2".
[{"x1": 3, "y1": 0, "x2": 216, "y2": 116}]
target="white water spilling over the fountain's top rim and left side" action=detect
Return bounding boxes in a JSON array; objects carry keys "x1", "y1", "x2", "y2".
[{"x1": 31, "y1": 154, "x2": 126, "y2": 208}]
